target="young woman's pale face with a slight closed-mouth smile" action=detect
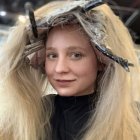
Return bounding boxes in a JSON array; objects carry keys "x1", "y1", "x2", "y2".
[{"x1": 45, "y1": 25, "x2": 97, "y2": 96}]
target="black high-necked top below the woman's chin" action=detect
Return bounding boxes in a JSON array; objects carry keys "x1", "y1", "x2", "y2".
[{"x1": 51, "y1": 93, "x2": 97, "y2": 140}]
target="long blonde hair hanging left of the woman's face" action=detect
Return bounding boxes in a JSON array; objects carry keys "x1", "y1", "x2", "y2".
[{"x1": 0, "y1": 25, "x2": 51, "y2": 140}]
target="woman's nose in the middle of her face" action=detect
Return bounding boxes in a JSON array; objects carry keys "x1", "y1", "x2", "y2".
[{"x1": 55, "y1": 57, "x2": 69, "y2": 73}]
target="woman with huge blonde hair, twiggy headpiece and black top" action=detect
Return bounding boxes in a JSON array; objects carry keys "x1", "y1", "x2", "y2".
[{"x1": 0, "y1": 1, "x2": 140, "y2": 140}]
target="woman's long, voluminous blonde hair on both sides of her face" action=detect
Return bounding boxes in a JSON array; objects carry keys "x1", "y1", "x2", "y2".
[{"x1": 0, "y1": 2, "x2": 140, "y2": 140}]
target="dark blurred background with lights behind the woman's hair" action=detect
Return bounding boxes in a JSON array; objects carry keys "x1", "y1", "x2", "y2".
[{"x1": 0, "y1": 0, "x2": 140, "y2": 46}]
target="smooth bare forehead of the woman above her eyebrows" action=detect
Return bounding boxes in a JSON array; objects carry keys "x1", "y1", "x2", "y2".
[{"x1": 46, "y1": 25, "x2": 90, "y2": 47}]
